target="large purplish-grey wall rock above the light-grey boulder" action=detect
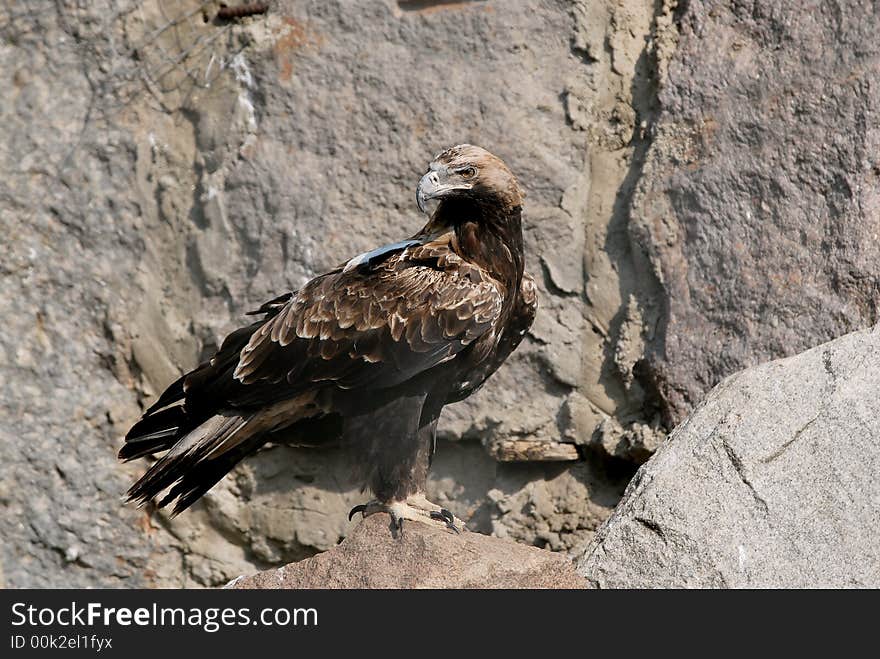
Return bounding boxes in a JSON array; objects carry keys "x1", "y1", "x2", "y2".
[{"x1": 629, "y1": 0, "x2": 880, "y2": 427}]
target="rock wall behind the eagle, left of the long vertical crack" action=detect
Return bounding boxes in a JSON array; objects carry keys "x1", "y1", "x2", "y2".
[{"x1": 0, "y1": 0, "x2": 668, "y2": 586}]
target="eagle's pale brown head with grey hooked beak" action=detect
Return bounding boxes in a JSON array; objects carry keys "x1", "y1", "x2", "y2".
[{"x1": 416, "y1": 144, "x2": 525, "y2": 216}]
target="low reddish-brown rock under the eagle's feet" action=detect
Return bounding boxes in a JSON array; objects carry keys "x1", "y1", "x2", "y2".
[{"x1": 228, "y1": 514, "x2": 586, "y2": 588}]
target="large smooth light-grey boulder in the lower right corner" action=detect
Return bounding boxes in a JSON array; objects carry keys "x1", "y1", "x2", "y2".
[{"x1": 577, "y1": 325, "x2": 880, "y2": 588}]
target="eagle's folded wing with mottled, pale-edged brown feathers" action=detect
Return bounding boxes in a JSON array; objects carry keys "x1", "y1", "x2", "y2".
[{"x1": 229, "y1": 241, "x2": 504, "y2": 405}]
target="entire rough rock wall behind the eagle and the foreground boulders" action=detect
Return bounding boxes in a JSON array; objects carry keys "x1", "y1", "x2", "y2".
[{"x1": 0, "y1": 0, "x2": 880, "y2": 586}]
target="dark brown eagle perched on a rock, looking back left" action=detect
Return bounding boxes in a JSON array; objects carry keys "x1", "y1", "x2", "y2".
[{"x1": 119, "y1": 144, "x2": 537, "y2": 531}]
